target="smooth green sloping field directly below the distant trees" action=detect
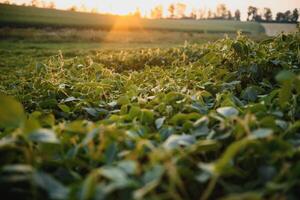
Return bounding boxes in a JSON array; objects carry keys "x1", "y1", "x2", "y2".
[{"x1": 0, "y1": 4, "x2": 264, "y2": 34}]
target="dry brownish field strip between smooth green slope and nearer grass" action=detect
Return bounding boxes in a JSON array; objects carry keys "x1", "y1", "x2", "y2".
[{"x1": 0, "y1": 28, "x2": 246, "y2": 46}]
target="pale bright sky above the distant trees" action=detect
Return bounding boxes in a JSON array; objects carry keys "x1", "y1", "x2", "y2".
[{"x1": 7, "y1": 0, "x2": 300, "y2": 19}]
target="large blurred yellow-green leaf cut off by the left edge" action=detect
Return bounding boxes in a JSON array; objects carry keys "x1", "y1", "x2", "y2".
[{"x1": 0, "y1": 95, "x2": 25, "y2": 128}]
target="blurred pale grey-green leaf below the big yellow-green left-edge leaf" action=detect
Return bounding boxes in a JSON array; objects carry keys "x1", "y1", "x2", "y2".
[{"x1": 28, "y1": 129, "x2": 60, "y2": 144}]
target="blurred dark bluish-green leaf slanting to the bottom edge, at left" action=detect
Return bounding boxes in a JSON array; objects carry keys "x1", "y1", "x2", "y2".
[{"x1": 33, "y1": 172, "x2": 69, "y2": 200}]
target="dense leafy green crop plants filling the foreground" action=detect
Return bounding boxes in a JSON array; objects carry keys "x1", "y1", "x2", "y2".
[{"x1": 0, "y1": 33, "x2": 300, "y2": 199}]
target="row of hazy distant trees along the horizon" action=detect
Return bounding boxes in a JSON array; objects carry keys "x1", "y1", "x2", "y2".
[{"x1": 3, "y1": 0, "x2": 299, "y2": 23}]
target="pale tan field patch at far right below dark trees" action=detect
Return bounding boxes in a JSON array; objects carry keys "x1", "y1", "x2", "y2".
[{"x1": 262, "y1": 23, "x2": 298, "y2": 36}]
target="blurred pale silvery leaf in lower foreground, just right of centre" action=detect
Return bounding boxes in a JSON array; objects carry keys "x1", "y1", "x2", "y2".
[{"x1": 163, "y1": 135, "x2": 196, "y2": 150}]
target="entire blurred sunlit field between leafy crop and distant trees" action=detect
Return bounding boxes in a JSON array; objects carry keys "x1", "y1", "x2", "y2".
[{"x1": 0, "y1": 4, "x2": 297, "y2": 66}]
